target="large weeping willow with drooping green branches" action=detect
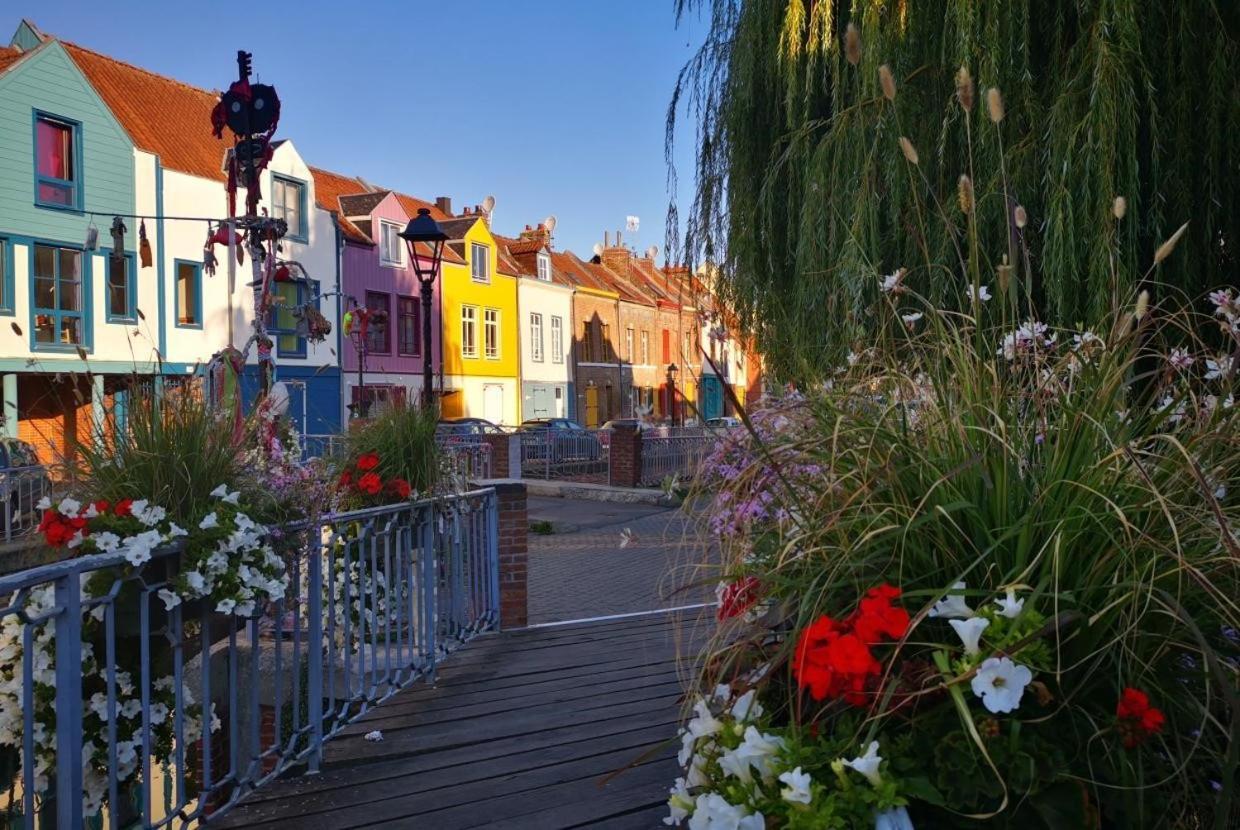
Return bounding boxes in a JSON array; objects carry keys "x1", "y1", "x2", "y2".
[{"x1": 667, "y1": 0, "x2": 1240, "y2": 378}]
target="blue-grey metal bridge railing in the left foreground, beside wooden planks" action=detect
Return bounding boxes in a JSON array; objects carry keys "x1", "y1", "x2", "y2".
[{"x1": 0, "y1": 490, "x2": 500, "y2": 830}]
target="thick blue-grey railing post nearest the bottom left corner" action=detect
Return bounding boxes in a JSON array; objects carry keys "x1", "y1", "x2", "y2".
[{"x1": 52, "y1": 572, "x2": 82, "y2": 830}]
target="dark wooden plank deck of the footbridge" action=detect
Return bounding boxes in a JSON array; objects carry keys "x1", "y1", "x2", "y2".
[{"x1": 210, "y1": 605, "x2": 706, "y2": 830}]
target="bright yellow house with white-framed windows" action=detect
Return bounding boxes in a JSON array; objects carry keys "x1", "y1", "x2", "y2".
[{"x1": 439, "y1": 213, "x2": 521, "y2": 424}]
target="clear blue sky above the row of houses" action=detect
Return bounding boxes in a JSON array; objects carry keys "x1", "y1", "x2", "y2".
[{"x1": 14, "y1": 0, "x2": 704, "y2": 259}]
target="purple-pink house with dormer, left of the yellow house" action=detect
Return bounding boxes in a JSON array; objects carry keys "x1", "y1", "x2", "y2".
[{"x1": 314, "y1": 169, "x2": 455, "y2": 414}]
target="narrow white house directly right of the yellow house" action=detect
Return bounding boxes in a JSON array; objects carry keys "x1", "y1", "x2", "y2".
[{"x1": 496, "y1": 223, "x2": 577, "y2": 419}]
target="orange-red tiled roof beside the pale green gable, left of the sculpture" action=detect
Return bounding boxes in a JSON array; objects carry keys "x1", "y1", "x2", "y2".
[{"x1": 61, "y1": 41, "x2": 229, "y2": 180}]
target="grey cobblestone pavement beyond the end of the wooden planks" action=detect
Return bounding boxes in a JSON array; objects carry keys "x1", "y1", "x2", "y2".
[{"x1": 529, "y1": 499, "x2": 715, "y2": 624}]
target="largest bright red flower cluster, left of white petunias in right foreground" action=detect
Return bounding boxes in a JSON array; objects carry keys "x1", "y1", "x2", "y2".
[{"x1": 792, "y1": 584, "x2": 909, "y2": 706}]
